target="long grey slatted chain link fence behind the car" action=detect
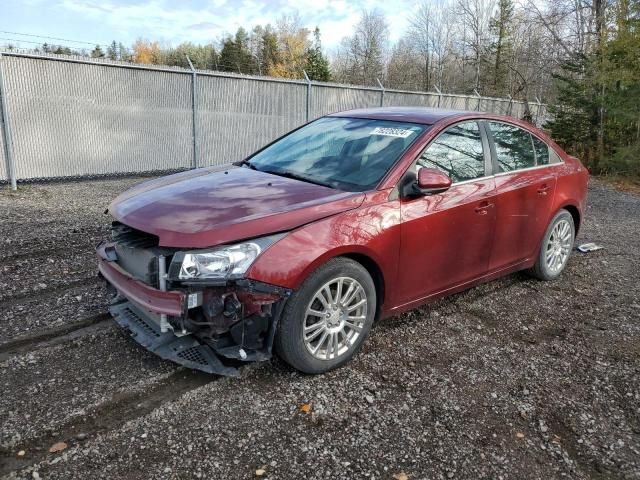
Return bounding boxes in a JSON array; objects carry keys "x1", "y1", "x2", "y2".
[{"x1": 0, "y1": 51, "x2": 546, "y2": 183}]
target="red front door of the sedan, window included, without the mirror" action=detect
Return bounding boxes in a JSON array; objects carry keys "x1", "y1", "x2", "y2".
[{"x1": 398, "y1": 121, "x2": 496, "y2": 304}]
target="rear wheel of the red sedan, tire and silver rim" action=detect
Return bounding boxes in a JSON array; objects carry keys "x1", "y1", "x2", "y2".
[{"x1": 528, "y1": 209, "x2": 576, "y2": 281}]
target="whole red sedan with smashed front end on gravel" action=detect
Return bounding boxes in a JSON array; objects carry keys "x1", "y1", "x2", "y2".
[{"x1": 98, "y1": 108, "x2": 588, "y2": 375}]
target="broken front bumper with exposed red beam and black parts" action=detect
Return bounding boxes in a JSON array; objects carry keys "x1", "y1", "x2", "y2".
[{"x1": 97, "y1": 242, "x2": 291, "y2": 376}]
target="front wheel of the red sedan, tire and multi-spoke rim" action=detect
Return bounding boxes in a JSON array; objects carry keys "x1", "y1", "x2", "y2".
[{"x1": 275, "y1": 257, "x2": 377, "y2": 374}]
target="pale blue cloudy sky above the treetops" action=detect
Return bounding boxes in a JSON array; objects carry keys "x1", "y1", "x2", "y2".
[{"x1": 0, "y1": 0, "x2": 417, "y2": 51}]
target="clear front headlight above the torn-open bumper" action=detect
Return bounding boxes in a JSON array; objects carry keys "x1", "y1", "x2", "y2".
[{"x1": 169, "y1": 234, "x2": 284, "y2": 280}]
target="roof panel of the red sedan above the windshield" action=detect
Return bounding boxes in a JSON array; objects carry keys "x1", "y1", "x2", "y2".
[{"x1": 329, "y1": 107, "x2": 482, "y2": 125}]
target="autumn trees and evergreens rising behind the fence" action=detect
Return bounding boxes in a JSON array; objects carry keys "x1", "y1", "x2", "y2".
[{"x1": 12, "y1": 0, "x2": 640, "y2": 176}]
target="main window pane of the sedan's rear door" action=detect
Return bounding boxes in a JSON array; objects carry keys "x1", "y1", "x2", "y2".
[{"x1": 489, "y1": 122, "x2": 536, "y2": 172}]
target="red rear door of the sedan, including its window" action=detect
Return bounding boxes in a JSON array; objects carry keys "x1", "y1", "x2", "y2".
[{"x1": 485, "y1": 122, "x2": 556, "y2": 271}]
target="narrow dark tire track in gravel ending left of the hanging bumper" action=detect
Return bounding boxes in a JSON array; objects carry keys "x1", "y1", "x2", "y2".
[{"x1": 0, "y1": 312, "x2": 115, "y2": 363}]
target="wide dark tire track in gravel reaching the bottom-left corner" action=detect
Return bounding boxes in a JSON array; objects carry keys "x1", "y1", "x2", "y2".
[{"x1": 0, "y1": 369, "x2": 221, "y2": 475}]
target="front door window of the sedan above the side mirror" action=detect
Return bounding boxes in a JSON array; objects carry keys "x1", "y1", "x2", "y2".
[{"x1": 418, "y1": 122, "x2": 484, "y2": 182}]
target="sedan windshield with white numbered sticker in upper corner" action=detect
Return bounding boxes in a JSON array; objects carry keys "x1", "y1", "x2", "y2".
[{"x1": 245, "y1": 117, "x2": 428, "y2": 192}]
